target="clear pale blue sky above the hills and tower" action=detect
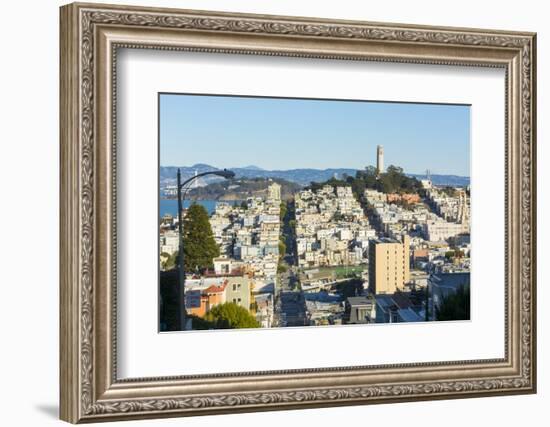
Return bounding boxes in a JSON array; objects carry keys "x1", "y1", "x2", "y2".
[{"x1": 159, "y1": 94, "x2": 470, "y2": 176}]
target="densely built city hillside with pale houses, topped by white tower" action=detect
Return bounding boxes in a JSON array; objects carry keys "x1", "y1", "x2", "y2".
[{"x1": 159, "y1": 146, "x2": 470, "y2": 331}]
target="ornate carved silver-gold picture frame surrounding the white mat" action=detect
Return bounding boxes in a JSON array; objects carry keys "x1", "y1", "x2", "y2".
[{"x1": 60, "y1": 4, "x2": 536, "y2": 423}]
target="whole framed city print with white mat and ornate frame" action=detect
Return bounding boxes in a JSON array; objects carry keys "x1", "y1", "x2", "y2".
[{"x1": 60, "y1": 4, "x2": 536, "y2": 423}]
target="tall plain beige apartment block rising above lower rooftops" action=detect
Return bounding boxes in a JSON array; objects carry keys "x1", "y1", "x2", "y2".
[{"x1": 369, "y1": 235, "x2": 410, "y2": 294}]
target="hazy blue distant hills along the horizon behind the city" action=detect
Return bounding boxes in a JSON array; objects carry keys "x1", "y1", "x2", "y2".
[{"x1": 160, "y1": 163, "x2": 470, "y2": 187}]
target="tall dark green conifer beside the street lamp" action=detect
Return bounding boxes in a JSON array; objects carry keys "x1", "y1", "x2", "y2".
[{"x1": 183, "y1": 203, "x2": 220, "y2": 271}]
